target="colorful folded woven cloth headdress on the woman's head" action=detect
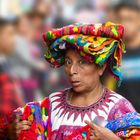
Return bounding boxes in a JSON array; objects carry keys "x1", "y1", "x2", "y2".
[{"x1": 43, "y1": 22, "x2": 124, "y2": 85}]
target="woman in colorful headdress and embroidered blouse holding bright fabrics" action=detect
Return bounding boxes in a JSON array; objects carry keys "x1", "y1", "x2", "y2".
[{"x1": 13, "y1": 22, "x2": 140, "y2": 140}]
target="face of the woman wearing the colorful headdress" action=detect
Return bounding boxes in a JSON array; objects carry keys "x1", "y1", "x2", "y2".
[{"x1": 64, "y1": 49, "x2": 105, "y2": 92}]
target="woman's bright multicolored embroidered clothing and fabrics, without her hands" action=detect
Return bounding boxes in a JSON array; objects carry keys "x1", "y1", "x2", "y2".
[{"x1": 16, "y1": 88, "x2": 140, "y2": 140}]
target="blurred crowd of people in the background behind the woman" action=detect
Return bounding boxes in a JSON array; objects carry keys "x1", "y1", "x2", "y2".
[{"x1": 0, "y1": 0, "x2": 140, "y2": 136}]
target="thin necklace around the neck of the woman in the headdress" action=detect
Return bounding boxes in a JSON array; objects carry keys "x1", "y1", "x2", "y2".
[{"x1": 67, "y1": 85, "x2": 104, "y2": 107}]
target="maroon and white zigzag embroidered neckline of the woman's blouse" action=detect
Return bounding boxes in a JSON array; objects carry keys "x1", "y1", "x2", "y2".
[{"x1": 52, "y1": 88, "x2": 116, "y2": 121}]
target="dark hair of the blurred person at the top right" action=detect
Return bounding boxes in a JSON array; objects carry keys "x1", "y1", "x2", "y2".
[{"x1": 112, "y1": 0, "x2": 140, "y2": 12}]
